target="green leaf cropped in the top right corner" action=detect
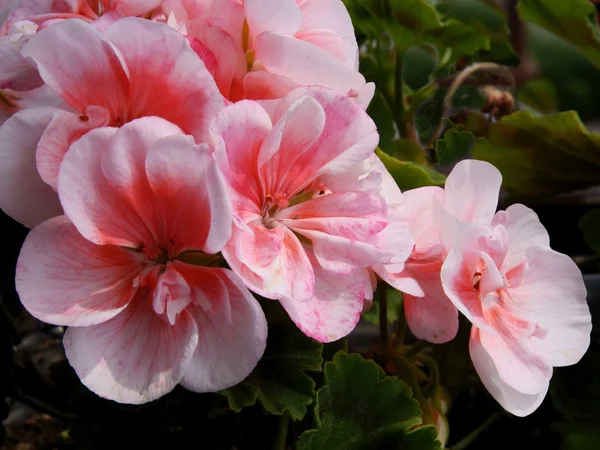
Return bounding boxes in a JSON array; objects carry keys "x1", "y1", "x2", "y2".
[{"x1": 518, "y1": 0, "x2": 600, "y2": 66}]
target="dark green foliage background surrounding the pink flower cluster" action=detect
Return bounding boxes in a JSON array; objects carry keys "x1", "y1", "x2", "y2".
[{"x1": 0, "y1": 0, "x2": 600, "y2": 450}]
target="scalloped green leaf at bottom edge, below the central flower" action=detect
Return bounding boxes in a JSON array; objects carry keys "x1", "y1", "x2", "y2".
[{"x1": 298, "y1": 352, "x2": 441, "y2": 450}]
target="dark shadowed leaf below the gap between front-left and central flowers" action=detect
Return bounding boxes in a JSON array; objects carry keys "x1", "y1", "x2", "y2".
[{"x1": 221, "y1": 320, "x2": 323, "y2": 420}]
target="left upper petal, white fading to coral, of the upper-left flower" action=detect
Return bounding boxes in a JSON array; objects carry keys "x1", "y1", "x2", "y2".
[{"x1": 22, "y1": 19, "x2": 130, "y2": 120}]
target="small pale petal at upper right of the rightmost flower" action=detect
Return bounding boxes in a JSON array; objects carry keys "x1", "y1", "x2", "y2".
[{"x1": 492, "y1": 204, "x2": 550, "y2": 270}]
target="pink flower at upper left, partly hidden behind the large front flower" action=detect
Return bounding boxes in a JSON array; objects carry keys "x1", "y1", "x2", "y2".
[{"x1": 0, "y1": 17, "x2": 224, "y2": 227}]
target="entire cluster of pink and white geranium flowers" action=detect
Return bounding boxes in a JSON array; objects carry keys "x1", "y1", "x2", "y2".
[{"x1": 0, "y1": 0, "x2": 591, "y2": 415}]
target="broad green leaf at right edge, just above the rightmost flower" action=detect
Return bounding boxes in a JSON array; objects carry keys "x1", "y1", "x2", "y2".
[{"x1": 473, "y1": 111, "x2": 600, "y2": 197}]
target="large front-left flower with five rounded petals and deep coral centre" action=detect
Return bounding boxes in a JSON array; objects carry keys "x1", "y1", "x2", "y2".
[{"x1": 16, "y1": 118, "x2": 267, "y2": 403}]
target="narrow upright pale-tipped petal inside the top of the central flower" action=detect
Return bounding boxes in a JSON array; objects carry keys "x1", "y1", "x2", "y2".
[{"x1": 257, "y1": 97, "x2": 325, "y2": 197}]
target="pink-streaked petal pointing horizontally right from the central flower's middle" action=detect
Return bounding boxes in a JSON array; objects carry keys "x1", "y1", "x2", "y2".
[{"x1": 277, "y1": 191, "x2": 388, "y2": 241}]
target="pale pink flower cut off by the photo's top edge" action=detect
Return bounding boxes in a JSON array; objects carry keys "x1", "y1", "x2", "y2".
[{"x1": 163, "y1": 0, "x2": 374, "y2": 108}]
